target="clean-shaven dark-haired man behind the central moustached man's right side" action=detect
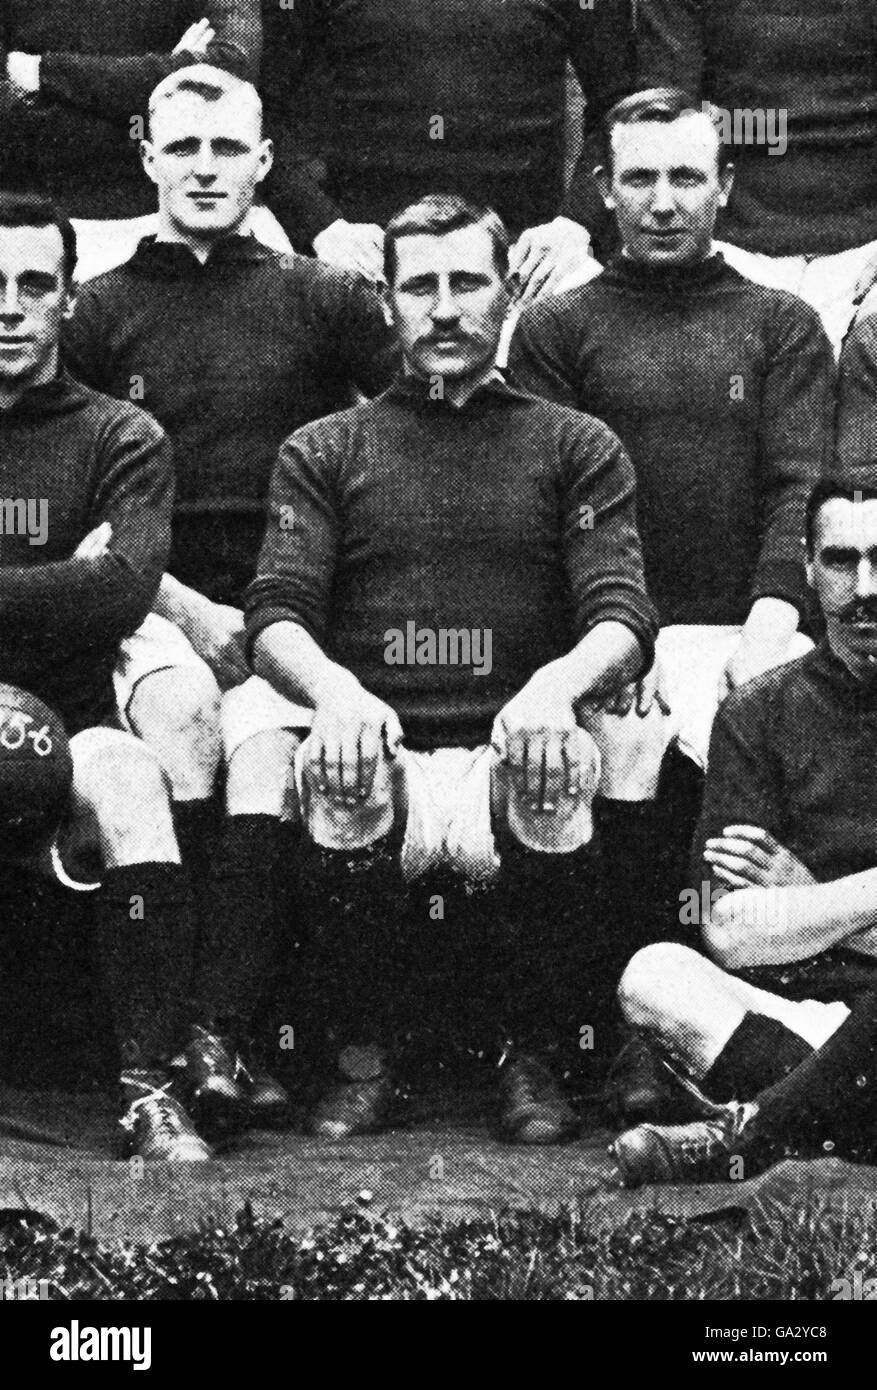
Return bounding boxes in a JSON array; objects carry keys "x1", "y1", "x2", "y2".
[{"x1": 510, "y1": 89, "x2": 834, "y2": 765}]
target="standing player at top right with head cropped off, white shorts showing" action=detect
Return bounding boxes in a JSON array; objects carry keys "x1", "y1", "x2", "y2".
[{"x1": 637, "y1": 0, "x2": 877, "y2": 354}]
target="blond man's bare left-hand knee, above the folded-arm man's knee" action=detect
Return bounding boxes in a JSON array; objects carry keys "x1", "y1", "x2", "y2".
[{"x1": 128, "y1": 662, "x2": 222, "y2": 801}]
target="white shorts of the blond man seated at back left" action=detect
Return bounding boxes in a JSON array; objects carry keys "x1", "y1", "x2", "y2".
[{"x1": 113, "y1": 613, "x2": 314, "y2": 762}]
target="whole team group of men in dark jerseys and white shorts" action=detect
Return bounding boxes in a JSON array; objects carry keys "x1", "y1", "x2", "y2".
[{"x1": 0, "y1": 0, "x2": 877, "y2": 1206}]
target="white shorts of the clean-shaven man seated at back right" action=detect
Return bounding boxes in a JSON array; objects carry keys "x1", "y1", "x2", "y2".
[{"x1": 656, "y1": 623, "x2": 813, "y2": 769}]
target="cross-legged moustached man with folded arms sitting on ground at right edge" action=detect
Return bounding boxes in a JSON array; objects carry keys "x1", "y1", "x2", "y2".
[{"x1": 614, "y1": 470, "x2": 877, "y2": 1186}]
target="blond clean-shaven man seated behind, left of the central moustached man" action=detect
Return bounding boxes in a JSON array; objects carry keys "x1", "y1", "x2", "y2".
[{"x1": 65, "y1": 64, "x2": 389, "y2": 1128}]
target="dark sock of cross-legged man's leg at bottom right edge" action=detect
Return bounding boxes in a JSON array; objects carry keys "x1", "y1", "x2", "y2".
[{"x1": 755, "y1": 991, "x2": 877, "y2": 1151}]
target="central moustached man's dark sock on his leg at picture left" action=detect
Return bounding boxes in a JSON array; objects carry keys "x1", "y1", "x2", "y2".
[{"x1": 299, "y1": 831, "x2": 407, "y2": 1047}]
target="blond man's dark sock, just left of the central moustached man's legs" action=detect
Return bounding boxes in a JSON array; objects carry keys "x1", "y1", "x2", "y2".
[{"x1": 192, "y1": 815, "x2": 291, "y2": 1036}]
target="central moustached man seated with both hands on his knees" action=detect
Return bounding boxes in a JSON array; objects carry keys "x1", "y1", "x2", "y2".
[{"x1": 247, "y1": 195, "x2": 653, "y2": 1143}]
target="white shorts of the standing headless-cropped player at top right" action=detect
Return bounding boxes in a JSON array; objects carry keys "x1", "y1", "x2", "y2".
[{"x1": 714, "y1": 233, "x2": 877, "y2": 357}]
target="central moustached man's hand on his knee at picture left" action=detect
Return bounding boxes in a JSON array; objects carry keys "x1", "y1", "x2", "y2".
[{"x1": 306, "y1": 677, "x2": 402, "y2": 806}]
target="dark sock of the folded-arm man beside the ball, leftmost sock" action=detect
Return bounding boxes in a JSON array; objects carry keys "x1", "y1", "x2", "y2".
[{"x1": 95, "y1": 863, "x2": 195, "y2": 1066}]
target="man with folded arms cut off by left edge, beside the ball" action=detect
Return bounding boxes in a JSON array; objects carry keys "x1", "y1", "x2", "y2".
[{"x1": 0, "y1": 195, "x2": 282, "y2": 1161}]
